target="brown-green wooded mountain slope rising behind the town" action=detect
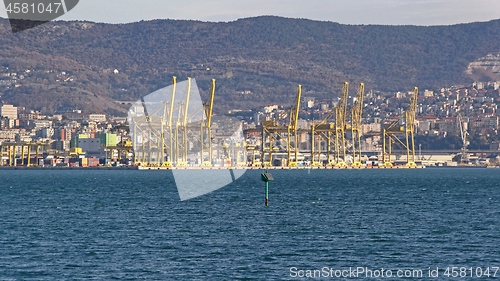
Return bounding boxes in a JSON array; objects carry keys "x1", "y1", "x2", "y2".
[{"x1": 0, "y1": 16, "x2": 500, "y2": 112}]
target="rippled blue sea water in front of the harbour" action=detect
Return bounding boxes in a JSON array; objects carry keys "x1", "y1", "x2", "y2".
[{"x1": 0, "y1": 169, "x2": 500, "y2": 280}]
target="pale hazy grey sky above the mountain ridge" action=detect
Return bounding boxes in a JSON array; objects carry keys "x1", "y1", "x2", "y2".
[{"x1": 0, "y1": 0, "x2": 500, "y2": 25}]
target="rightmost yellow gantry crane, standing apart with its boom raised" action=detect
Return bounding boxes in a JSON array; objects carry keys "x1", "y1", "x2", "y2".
[{"x1": 382, "y1": 87, "x2": 418, "y2": 167}]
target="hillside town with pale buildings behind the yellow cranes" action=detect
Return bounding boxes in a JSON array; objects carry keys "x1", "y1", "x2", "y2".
[{"x1": 0, "y1": 77, "x2": 500, "y2": 167}]
